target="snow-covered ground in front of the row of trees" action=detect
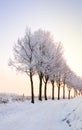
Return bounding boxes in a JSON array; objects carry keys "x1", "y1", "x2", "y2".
[{"x1": 0, "y1": 97, "x2": 82, "y2": 130}]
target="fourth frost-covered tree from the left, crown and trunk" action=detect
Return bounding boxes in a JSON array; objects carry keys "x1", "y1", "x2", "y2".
[{"x1": 44, "y1": 42, "x2": 63, "y2": 99}]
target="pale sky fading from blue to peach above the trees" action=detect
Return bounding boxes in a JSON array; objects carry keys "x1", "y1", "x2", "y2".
[{"x1": 0, "y1": 0, "x2": 82, "y2": 93}]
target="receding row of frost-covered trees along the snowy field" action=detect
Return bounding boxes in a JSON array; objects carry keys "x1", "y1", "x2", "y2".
[{"x1": 9, "y1": 28, "x2": 82, "y2": 103}]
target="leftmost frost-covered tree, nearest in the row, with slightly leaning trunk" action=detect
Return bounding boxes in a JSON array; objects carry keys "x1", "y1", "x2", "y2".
[{"x1": 9, "y1": 29, "x2": 35, "y2": 103}]
